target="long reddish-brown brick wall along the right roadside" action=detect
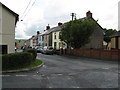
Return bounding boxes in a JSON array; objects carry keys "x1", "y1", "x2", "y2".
[{"x1": 61, "y1": 49, "x2": 120, "y2": 60}]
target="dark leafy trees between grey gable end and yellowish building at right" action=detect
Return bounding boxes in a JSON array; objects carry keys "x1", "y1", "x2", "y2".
[{"x1": 103, "y1": 28, "x2": 117, "y2": 43}]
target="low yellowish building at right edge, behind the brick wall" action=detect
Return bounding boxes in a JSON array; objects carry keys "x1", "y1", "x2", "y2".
[{"x1": 111, "y1": 31, "x2": 120, "y2": 50}]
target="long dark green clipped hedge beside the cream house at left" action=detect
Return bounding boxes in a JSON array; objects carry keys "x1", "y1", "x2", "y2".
[{"x1": 2, "y1": 52, "x2": 33, "y2": 70}]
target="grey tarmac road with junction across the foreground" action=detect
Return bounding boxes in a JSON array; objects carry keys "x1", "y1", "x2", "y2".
[{"x1": 2, "y1": 54, "x2": 118, "y2": 88}]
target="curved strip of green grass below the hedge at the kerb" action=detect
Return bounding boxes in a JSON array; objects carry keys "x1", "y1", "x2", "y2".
[{"x1": 4, "y1": 59, "x2": 43, "y2": 71}]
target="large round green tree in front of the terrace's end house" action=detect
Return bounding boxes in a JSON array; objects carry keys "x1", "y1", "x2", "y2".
[{"x1": 60, "y1": 19, "x2": 96, "y2": 48}]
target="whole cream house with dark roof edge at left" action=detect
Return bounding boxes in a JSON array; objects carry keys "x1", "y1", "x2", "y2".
[{"x1": 0, "y1": 2, "x2": 19, "y2": 54}]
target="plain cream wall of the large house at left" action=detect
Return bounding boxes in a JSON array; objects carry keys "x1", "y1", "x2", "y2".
[{"x1": 0, "y1": 7, "x2": 15, "y2": 53}]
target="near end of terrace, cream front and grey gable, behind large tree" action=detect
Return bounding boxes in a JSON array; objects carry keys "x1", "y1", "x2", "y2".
[{"x1": 41, "y1": 11, "x2": 103, "y2": 50}]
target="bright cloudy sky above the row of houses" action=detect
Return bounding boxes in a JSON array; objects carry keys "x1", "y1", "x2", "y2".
[{"x1": 0, "y1": 0, "x2": 119, "y2": 39}]
